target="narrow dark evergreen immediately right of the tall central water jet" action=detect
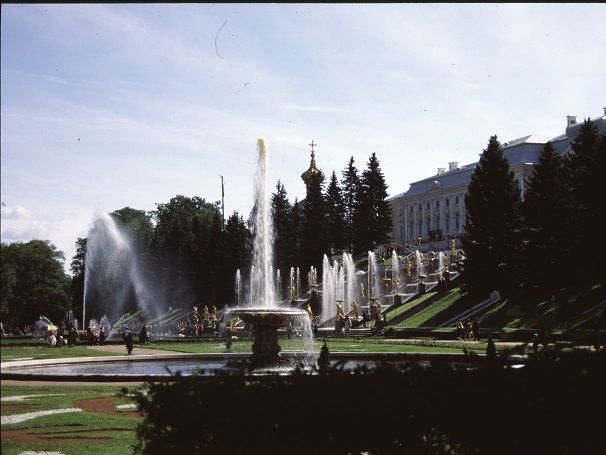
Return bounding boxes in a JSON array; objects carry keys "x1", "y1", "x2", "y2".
[{"x1": 271, "y1": 180, "x2": 292, "y2": 282}]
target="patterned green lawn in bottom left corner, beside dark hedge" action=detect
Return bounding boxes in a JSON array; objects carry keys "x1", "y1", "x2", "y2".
[{"x1": 1, "y1": 385, "x2": 141, "y2": 455}]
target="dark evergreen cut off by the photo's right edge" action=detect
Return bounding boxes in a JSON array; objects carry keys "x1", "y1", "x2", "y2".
[{"x1": 564, "y1": 119, "x2": 606, "y2": 284}]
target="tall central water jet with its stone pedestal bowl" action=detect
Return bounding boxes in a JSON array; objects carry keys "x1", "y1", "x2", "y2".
[{"x1": 226, "y1": 139, "x2": 311, "y2": 368}]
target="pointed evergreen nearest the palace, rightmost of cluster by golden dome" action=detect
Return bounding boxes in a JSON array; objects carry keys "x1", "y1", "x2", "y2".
[{"x1": 354, "y1": 153, "x2": 392, "y2": 254}]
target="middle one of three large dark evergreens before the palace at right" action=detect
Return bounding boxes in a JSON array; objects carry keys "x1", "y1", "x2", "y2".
[{"x1": 521, "y1": 142, "x2": 570, "y2": 291}]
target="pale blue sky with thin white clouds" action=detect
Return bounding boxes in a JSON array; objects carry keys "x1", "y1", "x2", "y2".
[{"x1": 0, "y1": 3, "x2": 606, "y2": 270}]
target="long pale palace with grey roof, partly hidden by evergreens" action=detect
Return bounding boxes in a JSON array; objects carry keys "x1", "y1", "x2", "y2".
[{"x1": 388, "y1": 108, "x2": 606, "y2": 249}]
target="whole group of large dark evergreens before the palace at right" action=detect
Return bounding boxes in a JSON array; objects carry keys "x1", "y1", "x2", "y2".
[{"x1": 462, "y1": 120, "x2": 606, "y2": 302}]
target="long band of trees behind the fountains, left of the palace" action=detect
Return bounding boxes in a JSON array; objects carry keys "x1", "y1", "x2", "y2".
[{"x1": 0, "y1": 153, "x2": 391, "y2": 325}]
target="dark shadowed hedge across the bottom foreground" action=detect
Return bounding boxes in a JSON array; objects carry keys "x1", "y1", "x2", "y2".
[{"x1": 132, "y1": 351, "x2": 606, "y2": 455}]
